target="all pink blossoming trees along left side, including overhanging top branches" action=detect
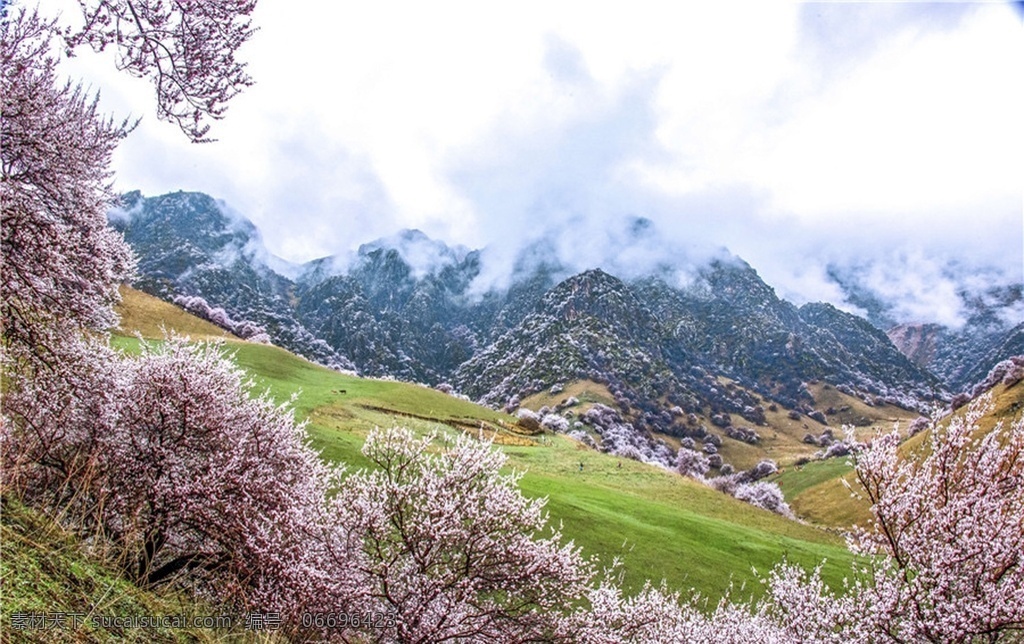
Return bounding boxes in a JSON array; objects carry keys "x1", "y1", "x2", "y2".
[{"x1": 0, "y1": 0, "x2": 335, "y2": 626}]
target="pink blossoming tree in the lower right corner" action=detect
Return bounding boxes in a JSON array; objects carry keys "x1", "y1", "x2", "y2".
[{"x1": 853, "y1": 397, "x2": 1024, "y2": 641}]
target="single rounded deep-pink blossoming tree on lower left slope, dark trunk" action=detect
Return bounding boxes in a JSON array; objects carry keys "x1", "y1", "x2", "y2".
[{"x1": 108, "y1": 339, "x2": 333, "y2": 611}]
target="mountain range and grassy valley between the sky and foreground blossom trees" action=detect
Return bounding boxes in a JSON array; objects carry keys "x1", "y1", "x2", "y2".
[{"x1": 99, "y1": 187, "x2": 1024, "y2": 598}]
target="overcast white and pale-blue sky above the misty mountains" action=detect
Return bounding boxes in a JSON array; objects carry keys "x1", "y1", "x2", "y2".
[{"x1": 48, "y1": 0, "x2": 1024, "y2": 321}]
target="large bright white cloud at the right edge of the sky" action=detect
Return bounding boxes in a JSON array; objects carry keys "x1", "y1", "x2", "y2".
[{"x1": 751, "y1": 5, "x2": 1024, "y2": 221}]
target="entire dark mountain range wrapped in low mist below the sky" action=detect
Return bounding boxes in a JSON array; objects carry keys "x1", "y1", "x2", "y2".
[{"x1": 111, "y1": 192, "x2": 1024, "y2": 417}]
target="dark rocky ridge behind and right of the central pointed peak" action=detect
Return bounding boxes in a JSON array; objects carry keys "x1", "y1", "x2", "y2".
[{"x1": 637, "y1": 261, "x2": 939, "y2": 406}]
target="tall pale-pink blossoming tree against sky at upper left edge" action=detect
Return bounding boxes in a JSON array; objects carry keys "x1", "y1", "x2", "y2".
[{"x1": 0, "y1": 11, "x2": 134, "y2": 367}]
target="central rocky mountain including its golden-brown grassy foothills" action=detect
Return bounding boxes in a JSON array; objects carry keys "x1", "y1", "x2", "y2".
[{"x1": 453, "y1": 266, "x2": 936, "y2": 469}]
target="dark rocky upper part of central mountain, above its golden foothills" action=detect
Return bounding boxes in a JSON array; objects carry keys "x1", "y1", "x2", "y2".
[{"x1": 455, "y1": 260, "x2": 941, "y2": 417}]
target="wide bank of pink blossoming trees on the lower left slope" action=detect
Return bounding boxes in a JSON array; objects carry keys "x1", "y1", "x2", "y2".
[{"x1": 0, "y1": 339, "x2": 346, "y2": 612}]
